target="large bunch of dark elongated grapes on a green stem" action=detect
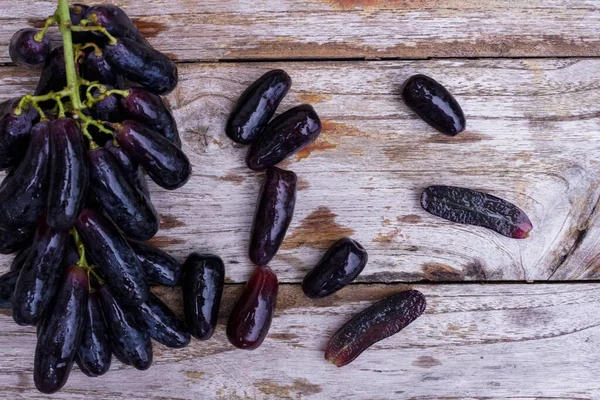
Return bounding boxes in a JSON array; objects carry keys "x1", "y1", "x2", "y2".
[{"x1": 0, "y1": 0, "x2": 195, "y2": 393}]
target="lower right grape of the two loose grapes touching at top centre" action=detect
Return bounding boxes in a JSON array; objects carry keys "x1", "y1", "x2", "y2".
[{"x1": 246, "y1": 104, "x2": 321, "y2": 171}]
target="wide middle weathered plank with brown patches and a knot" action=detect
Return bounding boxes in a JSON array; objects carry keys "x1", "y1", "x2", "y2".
[{"x1": 0, "y1": 59, "x2": 600, "y2": 282}]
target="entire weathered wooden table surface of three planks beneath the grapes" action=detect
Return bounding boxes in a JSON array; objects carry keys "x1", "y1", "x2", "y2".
[{"x1": 0, "y1": 0, "x2": 600, "y2": 399}]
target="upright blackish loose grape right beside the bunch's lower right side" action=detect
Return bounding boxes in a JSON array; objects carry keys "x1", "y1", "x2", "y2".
[{"x1": 182, "y1": 253, "x2": 225, "y2": 340}]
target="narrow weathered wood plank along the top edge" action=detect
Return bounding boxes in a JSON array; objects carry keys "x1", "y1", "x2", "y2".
[{"x1": 0, "y1": 0, "x2": 600, "y2": 62}]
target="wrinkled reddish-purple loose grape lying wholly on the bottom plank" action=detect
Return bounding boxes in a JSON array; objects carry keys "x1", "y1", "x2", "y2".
[{"x1": 325, "y1": 290, "x2": 426, "y2": 367}]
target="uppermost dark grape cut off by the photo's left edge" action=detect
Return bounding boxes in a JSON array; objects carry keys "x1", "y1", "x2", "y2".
[{"x1": 0, "y1": 98, "x2": 37, "y2": 169}]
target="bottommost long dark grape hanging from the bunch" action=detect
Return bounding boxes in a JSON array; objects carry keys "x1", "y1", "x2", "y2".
[{"x1": 33, "y1": 265, "x2": 88, "y2": 394}]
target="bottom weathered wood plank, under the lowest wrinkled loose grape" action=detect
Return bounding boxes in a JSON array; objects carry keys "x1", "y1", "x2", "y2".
[{"x1": 0, "y1": 284, "x2": 600, "y2": 399}]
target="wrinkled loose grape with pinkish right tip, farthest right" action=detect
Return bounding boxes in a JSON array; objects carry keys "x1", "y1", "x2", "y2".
[{"x1": 421, "y1": 186, "x2": 533, "y2": 239}]
